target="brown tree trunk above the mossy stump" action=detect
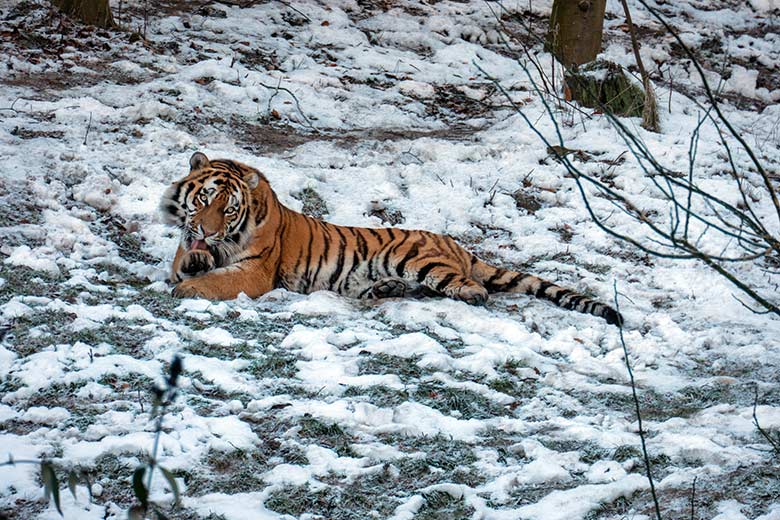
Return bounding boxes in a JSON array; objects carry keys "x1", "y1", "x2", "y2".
[{"x1": 547, "y1": 0, "x2": 607, "y2": 68}]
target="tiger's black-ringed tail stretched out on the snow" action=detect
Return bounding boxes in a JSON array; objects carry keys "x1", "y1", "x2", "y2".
[{"x1": 472, "y1": 260, "x2": 623, "y2": 326}]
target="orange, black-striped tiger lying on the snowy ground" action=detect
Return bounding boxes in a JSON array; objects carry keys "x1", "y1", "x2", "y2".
[{"x1": 160, "y1": 152, "x2": 623, "y2": 326}]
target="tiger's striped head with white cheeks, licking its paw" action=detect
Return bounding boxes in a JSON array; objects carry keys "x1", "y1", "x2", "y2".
[{"x1": 160, "y1": 152, "x2": 267, "y2": 267}]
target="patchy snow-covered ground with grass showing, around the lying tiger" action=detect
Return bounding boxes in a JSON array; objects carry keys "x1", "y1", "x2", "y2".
[{"x1": 0, "y1": 0, "x2": 780, "y2": 520}]
